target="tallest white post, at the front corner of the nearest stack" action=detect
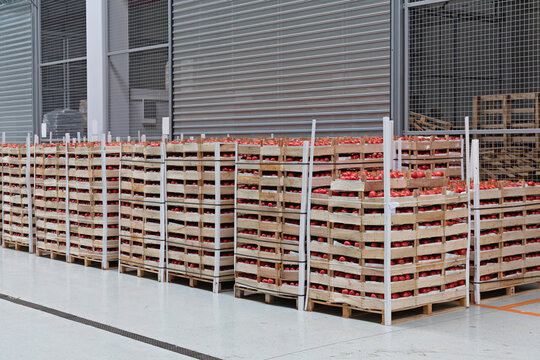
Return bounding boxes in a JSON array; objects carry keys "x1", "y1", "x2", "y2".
[{"x1": 383, "y1": 117, "x2": 394, "y2": 325}]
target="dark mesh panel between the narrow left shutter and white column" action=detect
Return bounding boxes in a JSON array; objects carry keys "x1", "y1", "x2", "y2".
[{"x1": 40, "y1": 0, "x2": 87, "y2": 140}]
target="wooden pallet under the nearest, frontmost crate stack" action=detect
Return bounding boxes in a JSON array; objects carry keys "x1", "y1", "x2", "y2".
[{"x1": 307, "y1": 297, "x2": 467, "y2": 325}]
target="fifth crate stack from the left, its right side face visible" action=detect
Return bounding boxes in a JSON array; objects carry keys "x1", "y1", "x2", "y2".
[{"x1": 166, "y1": 138, "x2": 236, "y2": 292}]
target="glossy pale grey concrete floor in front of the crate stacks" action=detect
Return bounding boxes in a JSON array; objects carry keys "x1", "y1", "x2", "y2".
[{"x1": 0, "y1": 249, "x2": 540, "y2": 360}]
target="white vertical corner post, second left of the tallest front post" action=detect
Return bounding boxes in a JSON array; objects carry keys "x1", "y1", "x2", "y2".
[{"x1": 212, "y1": 141, "x2": 221, "y2": 293}]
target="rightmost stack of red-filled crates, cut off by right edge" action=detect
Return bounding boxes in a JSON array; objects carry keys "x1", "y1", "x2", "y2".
[{"x1": 471, "y1": 181, "x2": 540, "y2": 303}]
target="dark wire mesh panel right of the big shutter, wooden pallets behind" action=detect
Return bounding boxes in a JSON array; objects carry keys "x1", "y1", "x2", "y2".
[{"x1": 405, "y1": 0, "x2": 540, "y2": 180}]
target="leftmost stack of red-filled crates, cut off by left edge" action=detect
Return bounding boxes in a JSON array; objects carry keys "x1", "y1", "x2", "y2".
[{"x1": 2, "y1": 144, "x2": 35, "y2": 252}]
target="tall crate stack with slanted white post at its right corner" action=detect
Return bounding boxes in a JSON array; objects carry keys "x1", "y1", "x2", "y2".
[{"x1": 235, "y1": 139, "x2": 309, "y2": 306}]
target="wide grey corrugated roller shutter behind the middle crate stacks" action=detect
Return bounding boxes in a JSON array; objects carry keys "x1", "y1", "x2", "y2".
[{"x1": 173, "y1": 0, "x2": 390, "y2": 136}]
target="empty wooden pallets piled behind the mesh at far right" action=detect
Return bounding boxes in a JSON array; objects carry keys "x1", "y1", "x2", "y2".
[{"x1": 472, "y1": 93, "x2": 540, "y2": 181}]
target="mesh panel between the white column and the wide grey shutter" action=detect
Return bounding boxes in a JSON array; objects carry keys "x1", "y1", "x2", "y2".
[{"x1": 108, "y1": 0, "x2": 170, "y2": 138}]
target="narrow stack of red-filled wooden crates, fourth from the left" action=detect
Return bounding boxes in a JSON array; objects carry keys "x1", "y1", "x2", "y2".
[{"x1": 120, "y1": 142, "x2": 166, "y2": 278}]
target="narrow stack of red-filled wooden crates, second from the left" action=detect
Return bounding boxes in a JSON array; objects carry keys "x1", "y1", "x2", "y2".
[{"x1": 34, "y1": 144, "x2": 67, "y2": 258}]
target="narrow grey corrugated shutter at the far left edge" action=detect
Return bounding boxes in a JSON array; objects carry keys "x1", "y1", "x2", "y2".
[{"x1": 0, "y1": 1, "x2": 33, "y2": 142}]
